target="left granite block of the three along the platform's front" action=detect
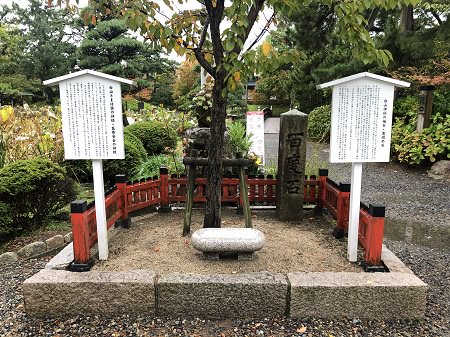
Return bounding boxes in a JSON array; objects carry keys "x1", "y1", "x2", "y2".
[{"x1": 23, "y1": 269, "x2": 156, "y2": 318}]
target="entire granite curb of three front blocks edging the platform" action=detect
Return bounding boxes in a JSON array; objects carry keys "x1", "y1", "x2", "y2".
[{"x1": 23, "y1": 245, "x2": 428, "y2": 319}]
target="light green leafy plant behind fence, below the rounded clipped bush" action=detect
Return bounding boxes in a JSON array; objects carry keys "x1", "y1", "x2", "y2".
[{"x1": 133, "y1": 154, "x2": 184, "y2": 179}]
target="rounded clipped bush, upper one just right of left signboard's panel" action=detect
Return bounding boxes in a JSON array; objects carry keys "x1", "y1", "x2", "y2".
[{"x1": 125, "y1": 122, "x2": 177, "y2": 155}]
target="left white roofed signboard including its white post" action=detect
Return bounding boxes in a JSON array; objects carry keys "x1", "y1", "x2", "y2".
[{"x1": 44, "y1": 69, "x2": 134, "y2": 260}]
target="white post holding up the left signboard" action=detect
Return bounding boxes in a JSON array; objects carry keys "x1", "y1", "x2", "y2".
[{"x1": 92, "y1": 159, "x2": 108, "y2": 260}]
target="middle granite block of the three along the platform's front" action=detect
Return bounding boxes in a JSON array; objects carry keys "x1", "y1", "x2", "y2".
[{"x1": 158, "y1": 272, "x2": 288, "y2": 318}]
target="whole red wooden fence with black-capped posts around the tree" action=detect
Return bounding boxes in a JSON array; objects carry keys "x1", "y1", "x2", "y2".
[{"x1": 70, "y1": 168, "x2": 384, "y2": 271}]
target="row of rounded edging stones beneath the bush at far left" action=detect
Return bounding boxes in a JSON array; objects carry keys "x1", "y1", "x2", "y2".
[{"x1": 0, "y1": 232, "x2": 72, "y2": 266}]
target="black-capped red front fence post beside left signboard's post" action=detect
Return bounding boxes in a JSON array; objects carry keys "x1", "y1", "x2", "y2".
[{"x1": 69, "y1": 200, "x2": 93, "y2": 272}]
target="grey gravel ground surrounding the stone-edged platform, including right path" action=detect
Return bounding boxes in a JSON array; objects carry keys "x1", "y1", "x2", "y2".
[{"x1": 0, "y1": 138, "x2": 450, "y2": 337}]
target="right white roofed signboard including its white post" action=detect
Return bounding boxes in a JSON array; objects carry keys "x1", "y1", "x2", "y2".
[{"x1": 317, "y1": 72, "x2": 410, "y2": 262}]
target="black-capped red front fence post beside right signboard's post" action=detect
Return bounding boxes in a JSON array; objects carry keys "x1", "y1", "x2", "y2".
[{"x1": 364, "y1": 204, "x2": 386, "y2": 271}]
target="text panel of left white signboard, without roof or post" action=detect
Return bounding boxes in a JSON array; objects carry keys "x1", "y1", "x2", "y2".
[{"x1": 59, "y1": 74, "x2": 125, "y2": 159}]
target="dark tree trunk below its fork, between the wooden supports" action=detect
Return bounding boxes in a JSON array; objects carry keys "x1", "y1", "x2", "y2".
[{"x1": 203, "y1": 71, "x2": 227, "y2": 228}]
